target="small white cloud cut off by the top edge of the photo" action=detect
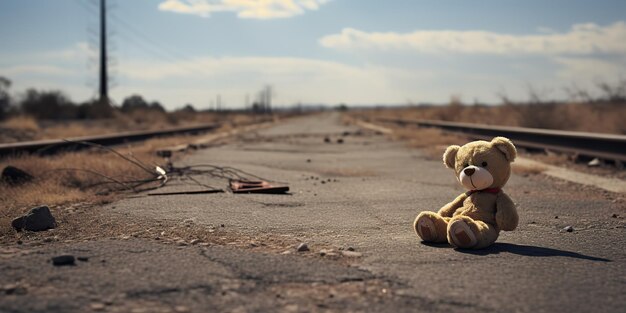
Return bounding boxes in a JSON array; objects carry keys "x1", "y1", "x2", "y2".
[{"x1": 159, "y1": 0, "x2": 330, "y2": 19}]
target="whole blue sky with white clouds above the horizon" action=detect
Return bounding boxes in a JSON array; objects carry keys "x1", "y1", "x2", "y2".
[{"x1": 0, "y1": 0, "x2": 626, "y2": 109}]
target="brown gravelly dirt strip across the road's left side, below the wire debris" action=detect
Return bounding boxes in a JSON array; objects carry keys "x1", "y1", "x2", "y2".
[{"x1": 0, "y1": 197, "x2": 359, "y2": 263}]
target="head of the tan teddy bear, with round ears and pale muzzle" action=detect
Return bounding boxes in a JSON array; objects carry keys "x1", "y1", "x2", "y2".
[{"x1": 443, "y1": 137, "x2": 517, "y2": 190}]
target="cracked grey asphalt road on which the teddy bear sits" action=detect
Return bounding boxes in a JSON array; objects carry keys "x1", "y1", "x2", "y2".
[{"x1": 0, "y1": 114, "x2": 626, "y2": 312}]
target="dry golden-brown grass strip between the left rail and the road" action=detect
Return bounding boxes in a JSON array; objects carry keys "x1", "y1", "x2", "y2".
[{"x1": 0, "y1": 122, "x2": 244, "y2": 227}]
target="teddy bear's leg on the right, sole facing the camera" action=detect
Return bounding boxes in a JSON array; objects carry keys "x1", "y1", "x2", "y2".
[{"x1": 447, "y1": 216, "x2": 498, "y2": 249}]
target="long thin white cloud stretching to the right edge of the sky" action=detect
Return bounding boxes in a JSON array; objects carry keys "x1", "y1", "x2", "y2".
[{"x1": 319, "y1": 22, "x2": 626, "y2": 55}]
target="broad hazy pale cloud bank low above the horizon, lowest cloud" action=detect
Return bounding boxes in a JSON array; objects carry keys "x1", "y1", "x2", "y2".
[{"x1": 114, "y1": 57, "x2": 402, "y2": 107}]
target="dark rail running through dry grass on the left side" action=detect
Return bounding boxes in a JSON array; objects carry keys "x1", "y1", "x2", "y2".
[{"x1": 0, "y1": 123, "x2": 222, "y2": 158}]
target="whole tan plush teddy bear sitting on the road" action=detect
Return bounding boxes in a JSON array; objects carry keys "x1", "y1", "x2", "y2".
[{"x1": 413, "y1": 137, "x2": 519, "y2": 249}]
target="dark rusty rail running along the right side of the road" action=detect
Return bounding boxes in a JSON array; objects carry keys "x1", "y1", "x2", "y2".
[{"x1": 375, "y1": 118, "x2": 626, "y2": 164}]
